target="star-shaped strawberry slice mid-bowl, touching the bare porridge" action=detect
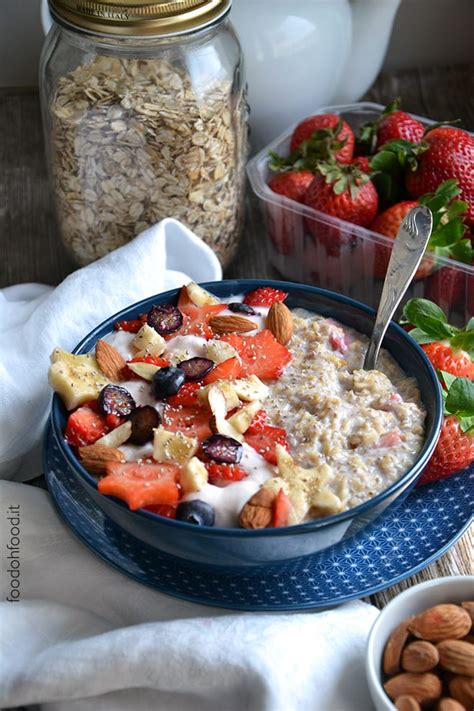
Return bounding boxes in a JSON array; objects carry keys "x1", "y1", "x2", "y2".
[{"x1": 221, "y1": 329, "x2": 291, "y2": 380}]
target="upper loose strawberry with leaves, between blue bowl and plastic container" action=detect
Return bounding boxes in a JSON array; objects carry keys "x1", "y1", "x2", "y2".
[{"x1": 403, "y1": 299, "x2": 474, "y2": 381}]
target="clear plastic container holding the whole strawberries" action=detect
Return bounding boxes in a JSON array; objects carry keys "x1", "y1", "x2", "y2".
[{"x1": 247, "y1": 102, "x2": 474, "y2": 324}]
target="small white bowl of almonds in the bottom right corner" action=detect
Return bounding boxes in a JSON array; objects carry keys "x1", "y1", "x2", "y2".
[{"x1": 366, "y1": 576, "x2": 474, "y2": 711}]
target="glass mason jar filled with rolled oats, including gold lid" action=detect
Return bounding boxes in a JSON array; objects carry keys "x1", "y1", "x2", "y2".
[{"x1": 40, "y1": 0, "x2": 247, "y2": 266}]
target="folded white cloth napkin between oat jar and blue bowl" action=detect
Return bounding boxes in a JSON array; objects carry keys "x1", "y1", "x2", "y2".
[{"x1": 0, "y1": 218, "x2": 222, "y2": 481}]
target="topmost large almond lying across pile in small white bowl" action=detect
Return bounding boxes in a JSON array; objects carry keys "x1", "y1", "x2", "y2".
[{"x1": 408, "y1": 604, "x2": 472, "y2": 642}]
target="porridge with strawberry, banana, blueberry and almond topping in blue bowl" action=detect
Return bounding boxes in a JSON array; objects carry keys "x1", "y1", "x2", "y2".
[{"x1": 49, "y1": 283, "x2": 425, "y2": 528}]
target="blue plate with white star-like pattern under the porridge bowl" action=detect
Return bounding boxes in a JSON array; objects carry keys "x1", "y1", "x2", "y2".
[{"x1": 45, "y1": 430, "x2": 474, "y2": 611}]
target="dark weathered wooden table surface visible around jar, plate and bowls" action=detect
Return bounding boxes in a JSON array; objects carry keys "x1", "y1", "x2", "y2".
[{"x1": 0, "y1": 65, "x2": 474, "y2": 640}]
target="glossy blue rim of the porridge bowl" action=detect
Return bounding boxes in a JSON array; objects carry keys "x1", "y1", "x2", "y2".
[{"x1": 50, "y1": 279, "x2": 443, "y2": 538}]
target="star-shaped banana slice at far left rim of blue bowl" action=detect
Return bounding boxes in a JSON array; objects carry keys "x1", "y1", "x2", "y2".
[{"x1": 48, "y1": 348, "x2": 110, "y2": 410}]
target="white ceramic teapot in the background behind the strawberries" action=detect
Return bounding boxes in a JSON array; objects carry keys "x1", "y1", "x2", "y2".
[{"x1": 231, "y1": 0, "x2": 400, "y2": 151}]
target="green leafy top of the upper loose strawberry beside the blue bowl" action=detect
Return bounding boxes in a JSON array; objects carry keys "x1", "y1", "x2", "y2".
[{"x1": 401, "y1": 299, "x2": 474, "y2": 358}]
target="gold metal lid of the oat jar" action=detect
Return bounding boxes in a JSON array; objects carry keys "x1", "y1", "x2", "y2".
[{"x1": 48, "y1": 0, "x2": 232, "y2": 37}]
